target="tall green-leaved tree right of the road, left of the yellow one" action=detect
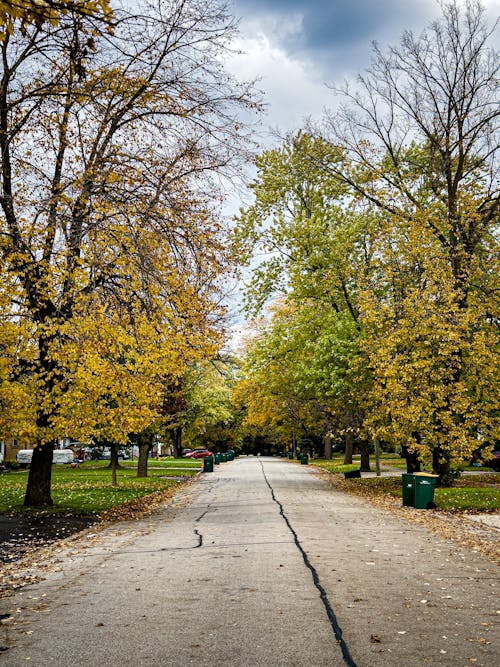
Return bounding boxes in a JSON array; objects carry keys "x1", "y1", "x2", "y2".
[{"x1": 237, "y1": 131, "x2": 375, "y2": 469}]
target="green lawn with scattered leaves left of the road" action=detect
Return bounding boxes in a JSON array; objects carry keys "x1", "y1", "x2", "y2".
[{"x1": 0, "y1": 459, "x2": 201, "y2": 516}]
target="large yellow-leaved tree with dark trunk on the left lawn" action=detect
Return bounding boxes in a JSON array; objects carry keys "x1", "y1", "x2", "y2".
[{"x1": 0, "y1": 0, "x2": 257, "y2": 505}]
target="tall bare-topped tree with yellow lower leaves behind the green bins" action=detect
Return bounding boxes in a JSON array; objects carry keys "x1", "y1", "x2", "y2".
[{"x1": 315, "y1": 0, "x2": 500, "y2": 479}]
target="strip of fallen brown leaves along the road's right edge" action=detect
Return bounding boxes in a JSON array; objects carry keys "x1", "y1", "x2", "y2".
[{"x1": 320, "y1": 471, "x2": 500, "y2": 563}]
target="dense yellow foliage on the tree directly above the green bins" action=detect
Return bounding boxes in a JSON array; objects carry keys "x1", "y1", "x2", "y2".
[{"x1": 361, "y1": 213, "x2": 499, "y2": 463}]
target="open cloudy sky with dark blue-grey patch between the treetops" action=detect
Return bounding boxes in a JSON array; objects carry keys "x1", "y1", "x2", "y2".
[{"x1": 229, "y1": 0, "x2": 500, "y2": 130}]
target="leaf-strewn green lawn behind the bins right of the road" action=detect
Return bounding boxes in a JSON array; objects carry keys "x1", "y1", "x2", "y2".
[{"x1": 314, "y1": 456, "x2": 500, "y2": 512}]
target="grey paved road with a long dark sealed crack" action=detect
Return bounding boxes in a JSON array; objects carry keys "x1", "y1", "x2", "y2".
[{"x1": 0, "y1": 458, "x2": 500, "y2": 667}]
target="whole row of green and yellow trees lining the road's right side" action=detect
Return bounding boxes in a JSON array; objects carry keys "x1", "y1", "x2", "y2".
[{"x1": 232, "y1": 0, "x2": 500, "y2": 484}]
